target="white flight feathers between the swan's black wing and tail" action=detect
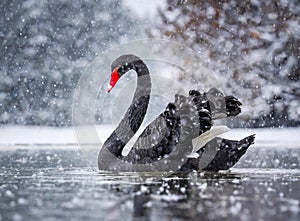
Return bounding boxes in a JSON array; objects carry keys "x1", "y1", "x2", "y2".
[{"x1": 193, "y1": 125, "x2": 229, "y2": 152}]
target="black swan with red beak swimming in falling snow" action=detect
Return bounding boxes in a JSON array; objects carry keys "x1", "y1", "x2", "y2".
[{"x1": 98, "y1": 54, "x2": 254, "y2": 172}]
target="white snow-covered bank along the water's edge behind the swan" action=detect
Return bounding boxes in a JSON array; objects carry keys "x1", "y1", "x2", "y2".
[{"x1": 0, "y1": 125, "x2": 300, "y2": 150}]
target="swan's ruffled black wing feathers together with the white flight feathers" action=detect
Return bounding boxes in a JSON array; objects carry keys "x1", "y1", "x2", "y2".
[{"x1": 127, "y1": 89, "x2": 243, "y2": 161}]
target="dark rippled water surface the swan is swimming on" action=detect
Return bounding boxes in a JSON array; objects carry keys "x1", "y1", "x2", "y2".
[{"x1": 0, "y1": 147, "x2": 300, "y2": 221}]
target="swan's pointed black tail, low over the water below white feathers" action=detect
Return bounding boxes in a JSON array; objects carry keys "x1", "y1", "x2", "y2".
[{"x1": 203, "y1": 134, "x2": 255, "y2": 172}]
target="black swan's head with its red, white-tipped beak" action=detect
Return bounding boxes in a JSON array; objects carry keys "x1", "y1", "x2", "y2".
[{"x1": 107, "y1": 54, "x2": 141, "y2": 92}]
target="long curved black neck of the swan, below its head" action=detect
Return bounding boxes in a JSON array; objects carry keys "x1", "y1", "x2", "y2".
[{"x1": 98, "y1": 60, "x2": 151, "y2": 159}]
